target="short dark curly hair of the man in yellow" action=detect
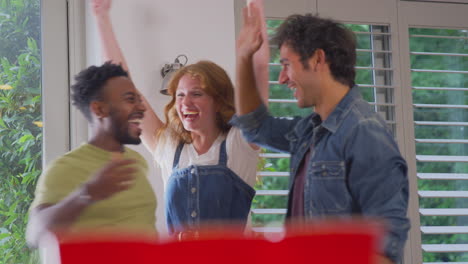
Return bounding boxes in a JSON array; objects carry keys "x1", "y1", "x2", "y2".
[{"x1": 71, "y1": 61, "x2": 128, "y2": 121}]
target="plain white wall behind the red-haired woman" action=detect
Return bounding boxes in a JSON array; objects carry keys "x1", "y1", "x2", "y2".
[{"x1": 86, "y1": 0, "x2": 235, "y2": 232}]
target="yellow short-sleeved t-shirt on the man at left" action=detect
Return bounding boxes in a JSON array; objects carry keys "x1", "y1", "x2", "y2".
[{"x1": 31, "y1": 144, "x2": 156, "y2": 235}]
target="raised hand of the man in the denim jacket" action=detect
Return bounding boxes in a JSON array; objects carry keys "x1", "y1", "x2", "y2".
[{"x1": 236, "y1": 3, "x2": 264, "y2": 58}]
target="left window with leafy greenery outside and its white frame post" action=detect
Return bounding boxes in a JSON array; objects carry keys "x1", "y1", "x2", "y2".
[{"x1": 0, "y1": 0, "x2": 68, "y2": 263}]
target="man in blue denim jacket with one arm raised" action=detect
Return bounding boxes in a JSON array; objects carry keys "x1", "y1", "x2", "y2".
[{"x1": 232, "y1": 5, "x2": 409, "y2": 263}]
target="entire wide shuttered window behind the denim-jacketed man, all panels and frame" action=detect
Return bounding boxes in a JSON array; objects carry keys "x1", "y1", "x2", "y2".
[{"x1": 238, "y1": 0, "x2": 468, "y2": 264}]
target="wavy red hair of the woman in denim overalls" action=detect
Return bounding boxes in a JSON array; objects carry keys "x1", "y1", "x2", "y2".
[{"x1": 156, "y1": 60, "x2": 235, "y2": 143}]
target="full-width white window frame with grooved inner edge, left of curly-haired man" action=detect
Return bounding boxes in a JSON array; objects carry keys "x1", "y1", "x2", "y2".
[{"x1": 41, "y1": 0, "x2": 89, "y2": 161}]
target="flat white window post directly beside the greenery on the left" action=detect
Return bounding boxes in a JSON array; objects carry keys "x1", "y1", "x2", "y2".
[{"x1": 41, "y1": 0, "x2": 70, "y2": 165}]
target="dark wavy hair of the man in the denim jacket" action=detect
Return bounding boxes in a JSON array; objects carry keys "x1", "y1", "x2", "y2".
[{"x1": 273, "y1": 14, "x2": 356, "y2": 87}]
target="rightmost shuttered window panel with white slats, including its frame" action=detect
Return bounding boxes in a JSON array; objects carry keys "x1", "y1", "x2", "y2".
[{"x1": 399, "y1": 2, "x2": 468, "y2": 263}]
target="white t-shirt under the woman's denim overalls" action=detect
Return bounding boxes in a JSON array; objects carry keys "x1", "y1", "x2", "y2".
[{"x1": 153, "y1": 127, "x2": 259, "y2": 188}]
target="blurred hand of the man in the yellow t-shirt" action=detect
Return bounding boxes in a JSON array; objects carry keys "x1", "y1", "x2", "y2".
[{"x1": 84, "y1": 159, "x2": 137, "y2": 201}]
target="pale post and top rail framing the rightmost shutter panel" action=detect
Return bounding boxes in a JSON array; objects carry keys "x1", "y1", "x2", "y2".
[{"x1": 398, "y1": 1, "x2": 468, "y2": 263}]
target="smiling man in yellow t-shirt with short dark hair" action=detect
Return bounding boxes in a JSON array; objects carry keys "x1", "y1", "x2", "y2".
[{"x1": 27, "y1": 63, "x2": 156, "y2": 246}]
